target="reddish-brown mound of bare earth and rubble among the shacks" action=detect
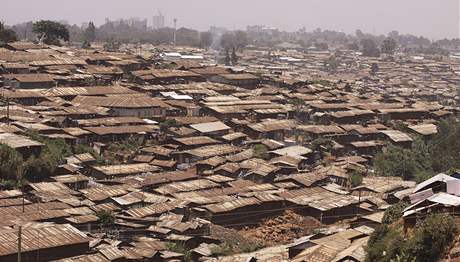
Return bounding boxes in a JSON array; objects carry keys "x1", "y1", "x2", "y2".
[{"x1": 240, "y1": 210, "x2": 321, "y2": 245}]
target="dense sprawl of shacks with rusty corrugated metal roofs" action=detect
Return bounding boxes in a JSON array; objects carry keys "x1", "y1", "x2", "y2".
[{"x1": 0, "y1": 42, "x2": 460, "y2": 262}]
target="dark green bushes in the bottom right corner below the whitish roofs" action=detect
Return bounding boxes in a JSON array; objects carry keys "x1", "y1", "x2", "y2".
[{"x1": 366, "y1": 214, "x2": 457, "y2": 262}]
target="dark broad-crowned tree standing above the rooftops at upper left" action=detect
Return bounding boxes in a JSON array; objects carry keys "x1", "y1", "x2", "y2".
[{"x1": 32, "y1": 20, "x2": 69, "y2": 45}]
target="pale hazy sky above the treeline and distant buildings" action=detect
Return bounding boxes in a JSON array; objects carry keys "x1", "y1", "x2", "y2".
[{"x1": 0, "y1": 0, "x2": 460, "y2": 39}]
